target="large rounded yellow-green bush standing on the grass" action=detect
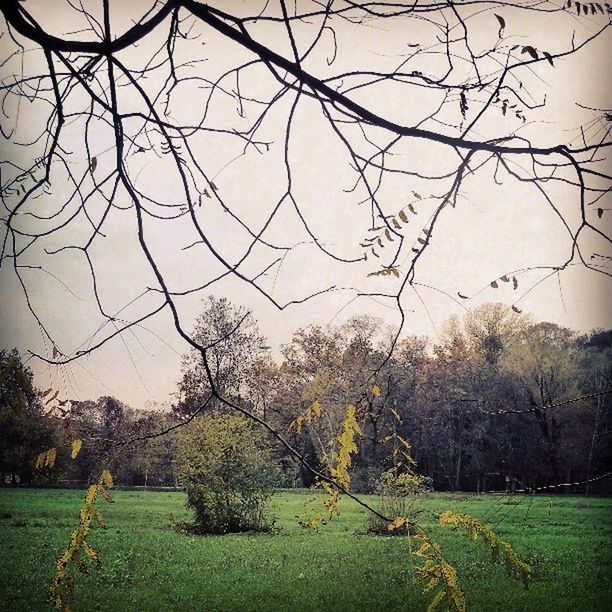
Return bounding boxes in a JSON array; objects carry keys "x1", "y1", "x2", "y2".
[{"x1": 179, "y1": 414, "x2": 279, "y2": 534}]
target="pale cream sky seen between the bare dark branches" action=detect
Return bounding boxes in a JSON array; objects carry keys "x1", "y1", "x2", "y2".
[{"x1": 0, "y1": 0, "x2": 612, "y2": 408}]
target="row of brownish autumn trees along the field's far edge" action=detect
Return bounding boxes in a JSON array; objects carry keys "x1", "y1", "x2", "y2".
[{"x1": 0, "y1": 297, "x2": 612, "y2": 493}]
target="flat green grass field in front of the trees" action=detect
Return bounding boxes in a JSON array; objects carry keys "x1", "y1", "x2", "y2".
[{"x1": 0, "y1": 489, "x2": 612, "y2": 612}]
